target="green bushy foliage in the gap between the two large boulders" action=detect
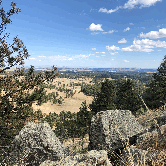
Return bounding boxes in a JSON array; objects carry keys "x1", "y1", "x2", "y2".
[{"x1": 52, "y1": 101, "x2": 92, "y2": 142}]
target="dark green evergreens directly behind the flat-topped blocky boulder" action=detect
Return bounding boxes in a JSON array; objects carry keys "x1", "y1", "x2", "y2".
[{"x1": 89, "y1": 79, "x2": 145, "y2": 115}]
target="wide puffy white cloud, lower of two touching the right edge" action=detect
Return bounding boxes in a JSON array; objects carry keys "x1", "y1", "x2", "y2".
[{"x1": 122, "y1": 39, "x2": 166, "y2": 52}]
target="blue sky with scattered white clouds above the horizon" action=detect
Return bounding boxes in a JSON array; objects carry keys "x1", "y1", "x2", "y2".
[{"x1": 1, "y1": 0, "x2": 166, "y2": 68}]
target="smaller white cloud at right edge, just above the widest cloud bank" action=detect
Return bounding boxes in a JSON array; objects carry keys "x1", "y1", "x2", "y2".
[{"x1": 140, "y1": 28, "x2": 166, "y2": 39}]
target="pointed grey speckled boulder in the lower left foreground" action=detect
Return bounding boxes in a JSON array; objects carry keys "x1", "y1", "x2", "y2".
[{"x1": 6, "y1": 122, "x2": 72, "y2": 165}]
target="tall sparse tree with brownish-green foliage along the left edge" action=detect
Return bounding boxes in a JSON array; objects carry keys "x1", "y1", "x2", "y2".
[{"x1": 0, "y1": 1, "x2": 58, "y2": 148}]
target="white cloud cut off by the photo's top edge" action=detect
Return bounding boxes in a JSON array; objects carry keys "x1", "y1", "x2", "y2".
[{"x1": 123, "y1": 0, "x2": 162, "y2": 9}]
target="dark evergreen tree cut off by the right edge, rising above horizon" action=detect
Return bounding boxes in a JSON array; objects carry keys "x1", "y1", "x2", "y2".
[{"x1": 143, "y1": 55, "x2": 166, "y2": 109}]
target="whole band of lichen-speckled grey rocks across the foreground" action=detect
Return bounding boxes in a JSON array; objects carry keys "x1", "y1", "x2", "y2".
[{"x1": 4, "y1": 110, "x2": 166, "y2": 166}]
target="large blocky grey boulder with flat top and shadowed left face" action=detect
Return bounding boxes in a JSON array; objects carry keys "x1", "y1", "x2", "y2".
[{"x1": 88, "y1": 110, "x2": 144, "y2": 152}]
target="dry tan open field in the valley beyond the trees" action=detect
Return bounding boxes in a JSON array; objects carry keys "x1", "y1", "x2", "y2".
[{"x1": 2, "y1": 77, "x2": 96, "y2": 114}]
